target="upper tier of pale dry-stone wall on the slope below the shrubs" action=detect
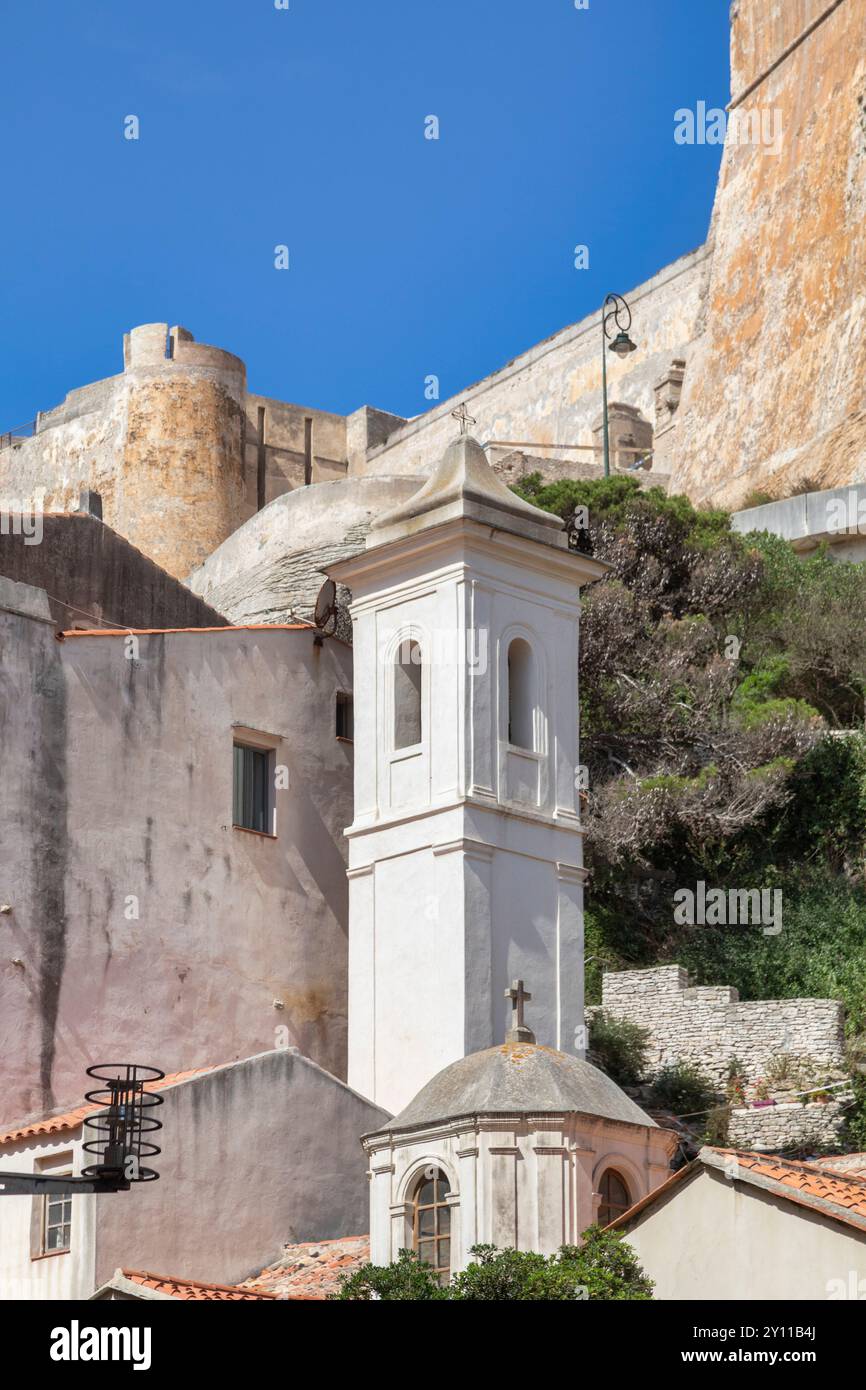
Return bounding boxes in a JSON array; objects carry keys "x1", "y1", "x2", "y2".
[{"x1": 587, "y1": 965, "x2": 844, "y2": 1088}]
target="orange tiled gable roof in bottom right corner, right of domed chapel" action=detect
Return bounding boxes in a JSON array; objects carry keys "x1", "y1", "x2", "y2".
[{"x1": 610, "y1": 1147, "x2": 866, "y2": 1232}]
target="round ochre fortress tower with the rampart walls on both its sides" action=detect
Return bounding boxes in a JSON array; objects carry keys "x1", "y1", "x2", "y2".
[{"x1": 0, "y1": 324, "x2": 355, "y2": 578}]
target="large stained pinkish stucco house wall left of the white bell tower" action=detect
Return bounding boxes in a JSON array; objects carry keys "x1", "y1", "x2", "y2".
[{"x1": 0, "y1": 591, "x2": 352, "y2": 1122}]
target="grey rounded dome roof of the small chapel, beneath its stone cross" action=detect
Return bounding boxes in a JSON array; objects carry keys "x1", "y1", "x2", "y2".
[{"x1": 385, "y1": 1043, "x2": 657, "y2": 1130}]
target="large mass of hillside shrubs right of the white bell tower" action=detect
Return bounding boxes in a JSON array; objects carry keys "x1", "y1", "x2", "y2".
[{"x1": 521, "y1": 474, "x2": 866, "y2": 1106}]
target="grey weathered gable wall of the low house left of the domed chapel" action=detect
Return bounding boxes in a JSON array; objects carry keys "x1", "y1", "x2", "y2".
[{"x1": 92, "y1": 1051, "x2": 388, "y2": 1283}]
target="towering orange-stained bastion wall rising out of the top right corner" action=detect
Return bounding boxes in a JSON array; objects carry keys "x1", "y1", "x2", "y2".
[{"x1": 671, "y1": 0, "x2": 866, "y2": 506}]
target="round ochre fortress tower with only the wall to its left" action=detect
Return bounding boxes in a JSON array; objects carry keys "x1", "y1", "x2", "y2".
[{"x1": 0, "y1": 324, "x2": 246, "y2": 578}]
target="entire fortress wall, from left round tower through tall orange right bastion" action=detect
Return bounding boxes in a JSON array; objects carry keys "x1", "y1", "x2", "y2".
[{"x1": 0, "y1": 0, "x2": 866, "y2": 589}]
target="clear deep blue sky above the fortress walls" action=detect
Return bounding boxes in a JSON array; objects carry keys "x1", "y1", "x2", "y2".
[{"x1": 0, "y1": 0, "x2": 728, "y2": 431}]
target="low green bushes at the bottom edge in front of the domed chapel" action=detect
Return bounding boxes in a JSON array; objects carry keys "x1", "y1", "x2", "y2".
[{"x1": 332, "y1": 1226, "x2": 653, "y2": 1302}]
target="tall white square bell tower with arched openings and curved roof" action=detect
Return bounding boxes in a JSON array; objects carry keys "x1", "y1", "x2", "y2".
[{"x1": 328, "y1": 435, "x2": 606, "y2": 1111}]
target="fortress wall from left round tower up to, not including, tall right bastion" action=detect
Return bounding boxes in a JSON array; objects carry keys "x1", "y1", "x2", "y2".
[{"x1": 0, "y1": 250, "x2": 708, "y2": 586}]
